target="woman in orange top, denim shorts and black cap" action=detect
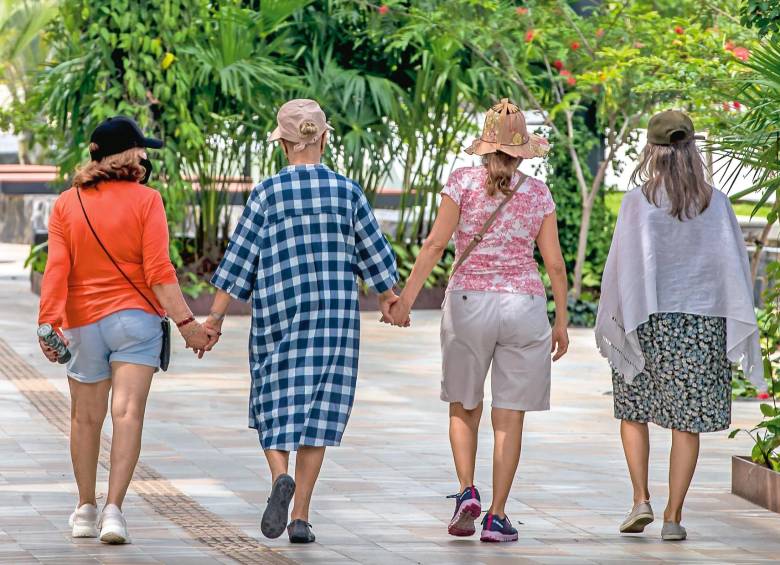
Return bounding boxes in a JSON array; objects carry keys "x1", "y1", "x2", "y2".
[{"x1": 38, "y1": 116, "x2": 211, "y2": 543}]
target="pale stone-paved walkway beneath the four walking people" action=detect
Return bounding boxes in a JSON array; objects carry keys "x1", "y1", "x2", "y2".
[{"x1": 0, "y1": 245, "x2": 780, "y2": 564}]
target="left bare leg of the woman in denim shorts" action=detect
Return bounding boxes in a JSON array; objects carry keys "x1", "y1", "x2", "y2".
[{"x1": 68, "y1": 378, "x2": 111, "y2": 506}]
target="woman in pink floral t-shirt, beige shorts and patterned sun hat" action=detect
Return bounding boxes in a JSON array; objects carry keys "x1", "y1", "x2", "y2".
[{"x1": 390, "y1": 99, "x2": 569, "y2": 542}]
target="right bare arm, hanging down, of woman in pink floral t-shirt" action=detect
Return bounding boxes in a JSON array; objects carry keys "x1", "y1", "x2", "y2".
[{"x1": 536, "y1": 212, "x2": 569, "y2": 361}]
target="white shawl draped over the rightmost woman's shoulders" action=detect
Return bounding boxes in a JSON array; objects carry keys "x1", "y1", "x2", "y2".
[{"x1": 596, "y1": 188, "x2": 766, "y2": 390}]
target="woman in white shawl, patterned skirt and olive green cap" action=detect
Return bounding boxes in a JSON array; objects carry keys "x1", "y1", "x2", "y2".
[{"x1": 596, "y1": 110, "x2": 766, "y2": 540}]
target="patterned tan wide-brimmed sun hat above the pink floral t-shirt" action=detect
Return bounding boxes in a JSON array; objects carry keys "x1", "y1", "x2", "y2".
[{"x1": 466, "y1": 98, "x2": 550, "y2": 159}]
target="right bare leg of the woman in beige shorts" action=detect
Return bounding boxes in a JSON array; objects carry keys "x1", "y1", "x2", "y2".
[{"x1": 488, "y1": 408, "x2": 525, "y2": 518}]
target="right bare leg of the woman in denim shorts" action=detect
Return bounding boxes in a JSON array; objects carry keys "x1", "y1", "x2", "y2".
[{"x1": 106, "y1": 362, "x2": 154, "y2": 508}]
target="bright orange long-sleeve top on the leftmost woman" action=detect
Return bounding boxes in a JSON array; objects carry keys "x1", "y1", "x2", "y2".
[{"x1": 38, "y1": 181, "x2": 177, "y2": 329}]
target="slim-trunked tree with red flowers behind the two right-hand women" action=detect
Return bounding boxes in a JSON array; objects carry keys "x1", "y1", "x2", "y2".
[{"x1": 396, "y1": 0, "x2": 749, "y2": 299}]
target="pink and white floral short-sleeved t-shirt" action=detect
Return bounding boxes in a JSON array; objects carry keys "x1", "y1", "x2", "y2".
[{"x1": 441, "y1": 166, "x2": 555, "y2": 296}]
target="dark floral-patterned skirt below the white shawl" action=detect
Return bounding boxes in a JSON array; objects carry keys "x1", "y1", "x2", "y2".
[{"x1": 612, "y1": 313, "x2": 731, "y2": 433}]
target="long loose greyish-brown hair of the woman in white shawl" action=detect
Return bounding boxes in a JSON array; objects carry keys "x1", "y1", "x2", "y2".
[{"x1": 631, "y1": 139, "x2": 712, "y2": 221}]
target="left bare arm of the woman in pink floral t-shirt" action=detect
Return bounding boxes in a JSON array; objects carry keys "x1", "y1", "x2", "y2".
[{"x1": 391, "y1": 195, "x2": 460, "y2": 324}]
